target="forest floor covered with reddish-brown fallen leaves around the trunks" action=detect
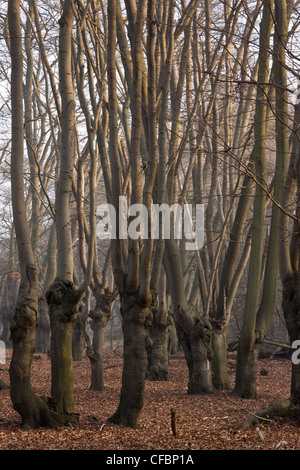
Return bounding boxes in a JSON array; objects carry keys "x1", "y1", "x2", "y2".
[{"x1": 0, "y1": 350, "x2": 300, "y2": 451}]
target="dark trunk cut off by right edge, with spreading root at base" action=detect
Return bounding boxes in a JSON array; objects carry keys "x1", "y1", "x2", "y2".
[{"x1": 240, "y1": 0, "x2": 300, "y2": 423}]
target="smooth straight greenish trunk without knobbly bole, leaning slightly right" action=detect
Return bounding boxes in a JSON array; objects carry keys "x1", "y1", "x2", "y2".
[{"x1": 233, "y1": 0, "x2": 274, "y2": 398}]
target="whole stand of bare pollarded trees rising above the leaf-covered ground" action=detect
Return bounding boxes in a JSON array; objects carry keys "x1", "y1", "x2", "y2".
[{"x1": 0, "y1": 0, "x2": 300, "y2": 452}]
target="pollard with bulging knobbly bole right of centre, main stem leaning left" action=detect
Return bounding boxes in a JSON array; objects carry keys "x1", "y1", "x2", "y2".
[{"x1": 158, "y1": 0, "x2": 213, "y2": 394}]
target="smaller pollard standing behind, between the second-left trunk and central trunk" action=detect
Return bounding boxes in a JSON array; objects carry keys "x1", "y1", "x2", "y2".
[{"x1": 75, "y1": 1, "x2": 117, "y2": 390}]
